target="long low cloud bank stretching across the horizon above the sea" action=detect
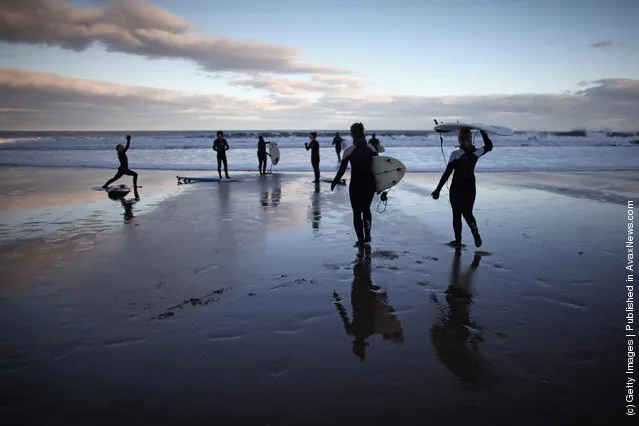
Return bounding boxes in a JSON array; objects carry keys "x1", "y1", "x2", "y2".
[{"x1": 0, "y1": 69, "x2": 639, "y2": 130}]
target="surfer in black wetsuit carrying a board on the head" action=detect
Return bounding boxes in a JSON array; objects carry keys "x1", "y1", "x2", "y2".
[{"x1": 432, "y1": 129, "x2": 493, "y2": 247}]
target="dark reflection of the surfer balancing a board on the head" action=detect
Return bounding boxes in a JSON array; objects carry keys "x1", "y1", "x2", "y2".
[{"x1": 430, "y1": 248, "x2": 485, "y2": 385}]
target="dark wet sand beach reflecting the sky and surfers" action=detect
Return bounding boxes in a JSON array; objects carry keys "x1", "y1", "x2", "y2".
[{"x1": 0, "y1": 169, "x2": 637, "y2": 425}]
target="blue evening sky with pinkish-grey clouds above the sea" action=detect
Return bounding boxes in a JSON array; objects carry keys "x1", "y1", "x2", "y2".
[{"x1": 0, "y1": 0, "x2": 639, "y2": 131}]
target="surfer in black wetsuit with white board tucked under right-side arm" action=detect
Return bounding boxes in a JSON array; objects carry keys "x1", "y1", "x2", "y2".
[{"x1": 331, "y1": 123, "x2": 377, "y2": 247}]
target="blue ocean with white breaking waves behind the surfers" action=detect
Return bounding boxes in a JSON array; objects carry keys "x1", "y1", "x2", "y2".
[{"x1": 0, "y1": 130, "x2": 639, "y2": 173}]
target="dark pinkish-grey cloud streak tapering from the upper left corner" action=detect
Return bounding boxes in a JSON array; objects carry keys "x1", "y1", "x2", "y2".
[{"x1": 0, "y1": 0, "x2": 350, "y2": 74}]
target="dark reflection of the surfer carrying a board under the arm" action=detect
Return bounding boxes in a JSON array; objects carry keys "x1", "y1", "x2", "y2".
[{"x1": 333, "y1": 246, "x2": 404, "y2": 362}]
